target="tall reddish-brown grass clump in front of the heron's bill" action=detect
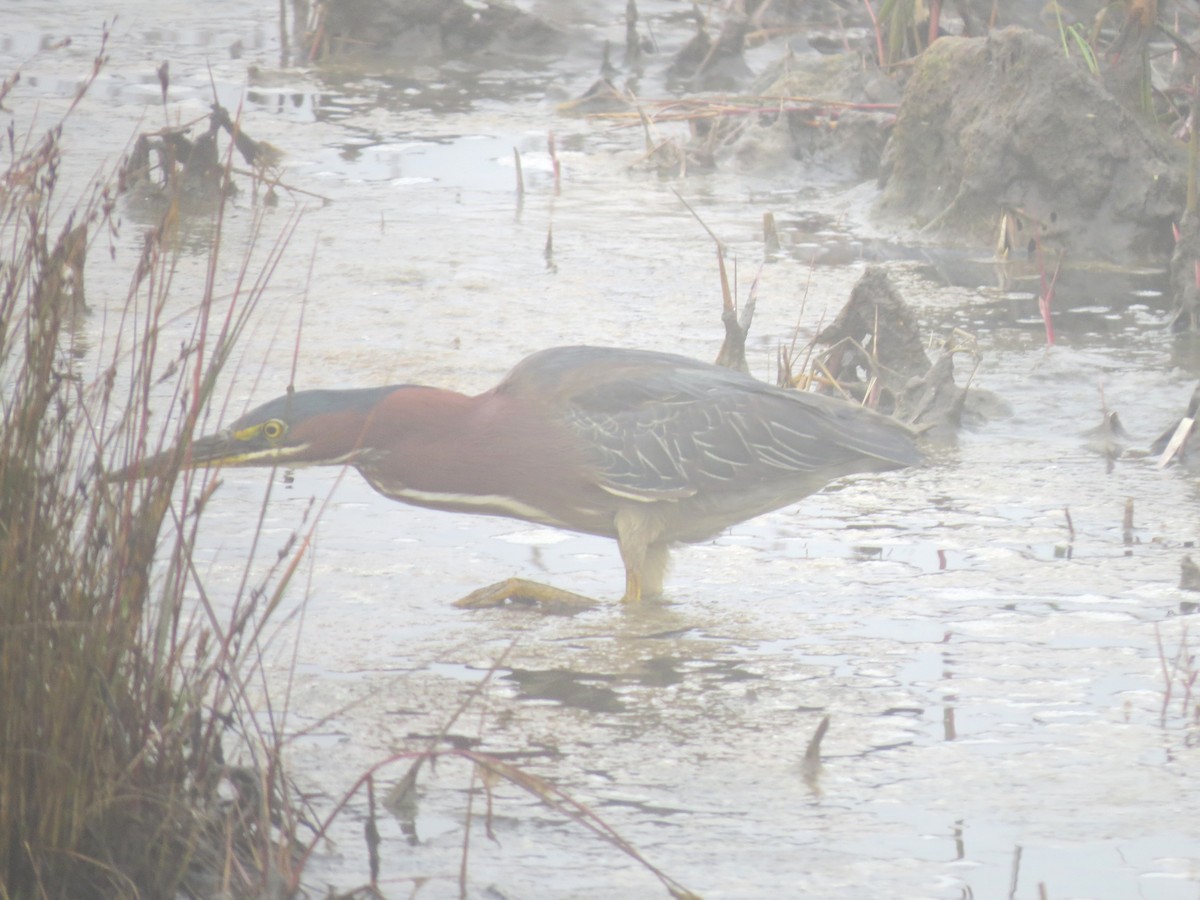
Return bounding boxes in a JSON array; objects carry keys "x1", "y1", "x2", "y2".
[{"x1": 0, "y1": 47, "x2": 304, "y2": 900}]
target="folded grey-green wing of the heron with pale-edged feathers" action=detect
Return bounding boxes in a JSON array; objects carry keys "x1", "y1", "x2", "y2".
[{"x1": 530, "y1": 348, "x2": 919, "y2": 502}]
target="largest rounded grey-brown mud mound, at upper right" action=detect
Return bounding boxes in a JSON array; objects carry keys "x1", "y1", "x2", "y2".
[{"x1": 876, "y1": 28, "x2": 1186, "y2": 259}]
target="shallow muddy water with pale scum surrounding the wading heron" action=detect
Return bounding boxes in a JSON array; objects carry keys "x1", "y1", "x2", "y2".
[{"x1": 9, "y1": 2, "x2": 1200, "y2": 899}]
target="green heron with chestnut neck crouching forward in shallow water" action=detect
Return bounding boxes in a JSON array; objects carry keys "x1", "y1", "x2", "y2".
[{"x1": 147, "y1": 347, "x2": 920, "y2": 606}]
